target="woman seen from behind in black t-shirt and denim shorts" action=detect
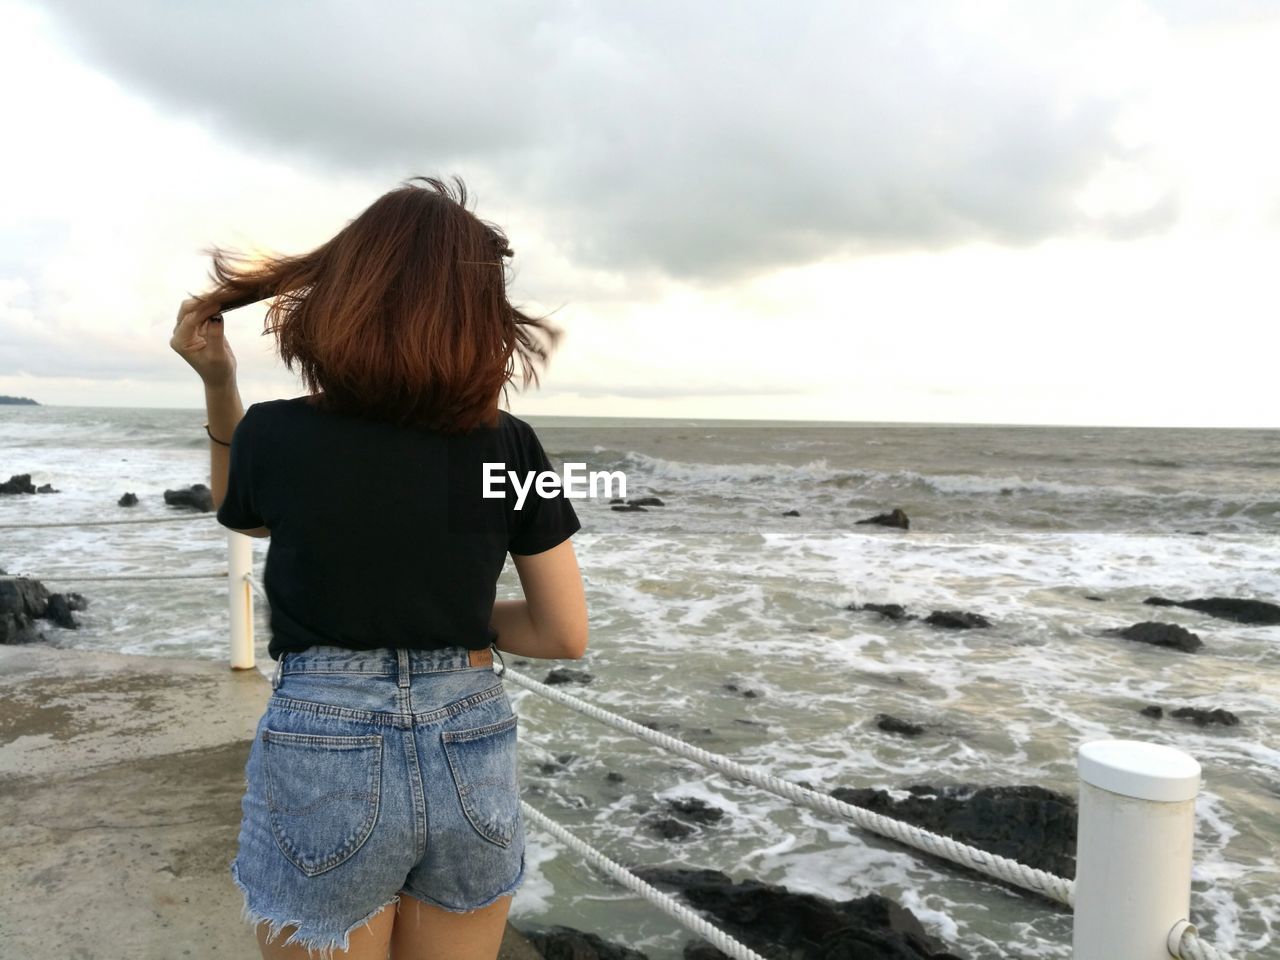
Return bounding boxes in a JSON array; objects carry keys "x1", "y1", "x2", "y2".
[{"x1": 170, "y1": 178, "x2": 588, "y2": 960}]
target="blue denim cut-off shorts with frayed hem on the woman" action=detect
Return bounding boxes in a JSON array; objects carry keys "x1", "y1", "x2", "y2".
[{"x1": 230, "y1": 646, "x2": 525, "y2": 957}]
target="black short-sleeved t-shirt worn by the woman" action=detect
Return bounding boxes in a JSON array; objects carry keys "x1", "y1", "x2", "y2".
[{"x1": 218, "y1": 397, "x2": 581, "y2": 660}]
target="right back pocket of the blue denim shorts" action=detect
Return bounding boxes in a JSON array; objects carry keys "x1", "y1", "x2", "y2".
[{"x1": 440, "y1": 714, "x2": 520, "y2": 846}]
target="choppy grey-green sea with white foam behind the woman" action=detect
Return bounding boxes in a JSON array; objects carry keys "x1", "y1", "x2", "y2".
[{"x1": 0, "y1": 406, "x2": 1280, "y2": 960}]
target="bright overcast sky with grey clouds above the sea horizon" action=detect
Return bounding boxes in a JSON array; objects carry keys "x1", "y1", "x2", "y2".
[{"x1": 0, "y1": 0, "x2": 1280, "y2": 428}]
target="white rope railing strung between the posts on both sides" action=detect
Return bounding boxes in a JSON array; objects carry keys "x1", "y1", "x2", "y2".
[{"x1": 0, "y1": 513, "x2": 1231, "y2": 960}]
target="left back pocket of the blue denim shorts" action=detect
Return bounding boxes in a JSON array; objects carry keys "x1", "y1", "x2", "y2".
[{"x1": 262, "y1": 727, "x2": 383, "y2": 877}]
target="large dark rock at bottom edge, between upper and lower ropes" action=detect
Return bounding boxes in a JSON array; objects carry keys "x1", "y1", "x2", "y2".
[{"x1": 634, "y1": 867, "x2": 959, "y2": 960}]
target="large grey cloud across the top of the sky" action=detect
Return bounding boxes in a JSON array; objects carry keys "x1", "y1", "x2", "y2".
[{"x1": 40, "y1": 0, "x2": 1176, "y2": 282}]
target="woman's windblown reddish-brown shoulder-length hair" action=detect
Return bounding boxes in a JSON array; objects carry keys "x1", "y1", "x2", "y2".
[{"x1": 205, "y1": 177, "x2": 561, "y2": 430}]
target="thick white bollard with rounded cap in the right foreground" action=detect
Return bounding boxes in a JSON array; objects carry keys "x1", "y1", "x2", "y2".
[{"x1": 1073, "y1": 740, "x2": 1201, "y2": 960}]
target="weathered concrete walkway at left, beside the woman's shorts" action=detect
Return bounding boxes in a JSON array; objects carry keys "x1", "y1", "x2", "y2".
[{"x1": 0, "y1": 644, "x2": 541, "y2": 960}]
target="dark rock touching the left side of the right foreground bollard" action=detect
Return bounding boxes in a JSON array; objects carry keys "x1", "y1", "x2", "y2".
[{"x1": 831, "y1": 785, "x2": 1076, "y2": 878}]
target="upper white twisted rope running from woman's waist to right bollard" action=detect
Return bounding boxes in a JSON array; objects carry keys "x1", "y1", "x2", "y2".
[{"x1": 504, "y1": 669, "x2": 1075, "y2": 906}]
